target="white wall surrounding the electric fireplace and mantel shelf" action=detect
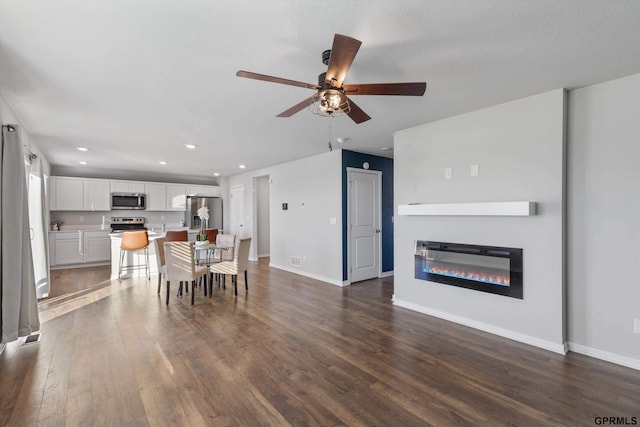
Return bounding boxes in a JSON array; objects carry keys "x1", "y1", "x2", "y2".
[{"x1": 394, "y1": 90, "x2": 565, "y2": 352}]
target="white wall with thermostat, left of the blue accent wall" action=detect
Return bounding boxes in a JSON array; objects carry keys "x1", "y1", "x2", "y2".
[{"x1": 229, "y1": 150, "x2": 342, "y2": 285}]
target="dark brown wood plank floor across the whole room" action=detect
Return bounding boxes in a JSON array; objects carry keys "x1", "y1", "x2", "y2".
[{"x1": 0, "y1": 261, "x2": 640, "y2": 426}]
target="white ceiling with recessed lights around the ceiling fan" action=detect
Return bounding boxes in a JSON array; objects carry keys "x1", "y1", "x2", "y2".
[{"x1": 0, "y1": 0, "x2": 640, "y2": 178}]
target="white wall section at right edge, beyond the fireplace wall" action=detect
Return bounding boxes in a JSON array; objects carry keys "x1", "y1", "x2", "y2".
[{"x1": 567, "y1": 74, "x2": 640, "y2": 369}]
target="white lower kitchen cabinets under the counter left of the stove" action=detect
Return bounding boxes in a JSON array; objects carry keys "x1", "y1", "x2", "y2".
[{"x1": 49, "y1": 230, "x2": 111, "y2": 267}]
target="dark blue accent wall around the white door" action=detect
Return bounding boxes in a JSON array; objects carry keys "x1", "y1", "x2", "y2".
[{"x1": 342, "y1": 150, "x2": 393, "y2": 280}]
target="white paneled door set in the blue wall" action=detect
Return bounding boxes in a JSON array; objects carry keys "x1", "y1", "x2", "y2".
[{"x1": 348, "y1": 169, "x2": 382, "y2": 282}]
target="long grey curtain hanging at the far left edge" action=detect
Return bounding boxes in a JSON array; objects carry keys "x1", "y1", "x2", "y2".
[{"x1": 0, "y1": 126, "x2": 40, "y2": 343}]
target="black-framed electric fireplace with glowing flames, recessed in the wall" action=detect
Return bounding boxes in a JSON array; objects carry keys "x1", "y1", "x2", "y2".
[{"x1": 415, "y1": 240, "x2": 522, "y2": 299}]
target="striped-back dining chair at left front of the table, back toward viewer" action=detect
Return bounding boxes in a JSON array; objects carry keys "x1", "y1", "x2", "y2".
[{"x1": 164, "y1": 242, "x2": 208, "y2": 305}]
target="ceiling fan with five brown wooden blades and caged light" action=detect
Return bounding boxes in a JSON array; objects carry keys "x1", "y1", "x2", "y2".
[{"x1": 236, "y1": 34, "x2": 427, "y2": 123}]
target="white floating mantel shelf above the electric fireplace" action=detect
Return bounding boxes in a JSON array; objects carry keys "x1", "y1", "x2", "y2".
[{"x1": 398, "y1": 202, "x2": 536, "y2": 216}]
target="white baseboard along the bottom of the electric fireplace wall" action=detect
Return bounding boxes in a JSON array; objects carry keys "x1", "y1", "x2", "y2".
[{"x1": 393, "y1": 298, "x2": 568, "y2": 354}]
